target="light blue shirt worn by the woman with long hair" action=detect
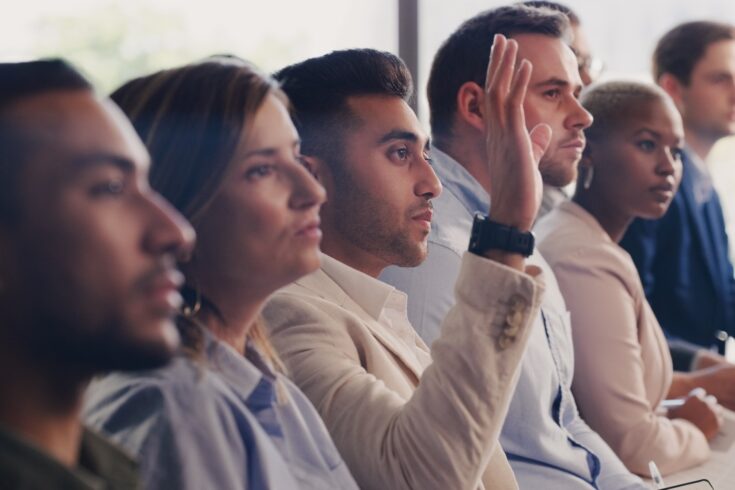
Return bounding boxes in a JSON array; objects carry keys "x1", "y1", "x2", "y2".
[{"x1": 85, "y1": 331, "x2": 357, "y2": 490}]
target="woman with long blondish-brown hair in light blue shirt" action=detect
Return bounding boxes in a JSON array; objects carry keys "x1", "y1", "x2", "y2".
[{"x1": 86, "y1": 57, "x2": 356, "y2": 490}]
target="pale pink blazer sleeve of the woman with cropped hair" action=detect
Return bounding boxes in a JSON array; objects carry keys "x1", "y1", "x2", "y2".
[{"x1": 554, "y1": 247, "x2": 709, "y2": 475}]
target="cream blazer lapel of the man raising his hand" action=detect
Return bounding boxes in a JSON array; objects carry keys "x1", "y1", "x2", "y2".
[{"x1": 296, "y1": 269, "x2": 426, "y2": 378}]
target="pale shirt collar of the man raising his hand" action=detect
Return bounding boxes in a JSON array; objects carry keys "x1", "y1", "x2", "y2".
[{"x1": 321, "y1": 254, "x2": 396, "y2": 320}]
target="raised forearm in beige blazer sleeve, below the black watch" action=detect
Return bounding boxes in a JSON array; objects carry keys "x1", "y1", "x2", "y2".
[{"x1": 366, "y1": 256, "x2": 540, "y2": 488}]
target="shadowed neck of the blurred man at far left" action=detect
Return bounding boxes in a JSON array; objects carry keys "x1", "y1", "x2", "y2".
[{"x1": 0, "y1": 342, "x2": 91, "y2": 467}]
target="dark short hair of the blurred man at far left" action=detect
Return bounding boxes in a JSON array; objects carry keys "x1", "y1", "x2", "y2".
[{"x1": 0, "y1": 59, "x2": 92, "y2": 224}]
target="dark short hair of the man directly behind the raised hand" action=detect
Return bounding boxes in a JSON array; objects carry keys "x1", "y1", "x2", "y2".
[{"x1": 426, "y1": 4, "x2": 569, "y2": 138}]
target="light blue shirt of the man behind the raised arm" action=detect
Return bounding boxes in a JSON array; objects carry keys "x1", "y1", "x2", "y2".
[{"x1": 380, "y1": 148, "x2": 648, "y2": 490}]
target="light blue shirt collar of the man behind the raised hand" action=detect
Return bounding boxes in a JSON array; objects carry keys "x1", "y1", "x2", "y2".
[{"x1": 431, "y1": 147, "x2": 490, "y2": 214}]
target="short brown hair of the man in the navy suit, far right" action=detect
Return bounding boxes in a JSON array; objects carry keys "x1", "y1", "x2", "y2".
[{"x1": 653, "y1": 21, "x2": 735, "y2": 85}]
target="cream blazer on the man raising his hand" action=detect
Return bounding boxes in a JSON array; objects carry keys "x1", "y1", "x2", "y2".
[{"x1": 264, "y1": 253, "x2": 543, "y2": 490}]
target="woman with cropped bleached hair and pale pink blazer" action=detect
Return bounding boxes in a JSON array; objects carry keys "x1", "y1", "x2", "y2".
[{"x1": 536, "y1": 82, "x2": 721, "y2": 475}]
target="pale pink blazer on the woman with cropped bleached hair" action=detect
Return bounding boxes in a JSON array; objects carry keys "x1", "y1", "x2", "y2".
[{"x1": 534, "y1": 201, "x2": 709, "y2": 475}]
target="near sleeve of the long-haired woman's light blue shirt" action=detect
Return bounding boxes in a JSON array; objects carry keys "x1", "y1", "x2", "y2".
[{"x1": 85, "y1": 373, "x2": 297, "y2": 490}]
